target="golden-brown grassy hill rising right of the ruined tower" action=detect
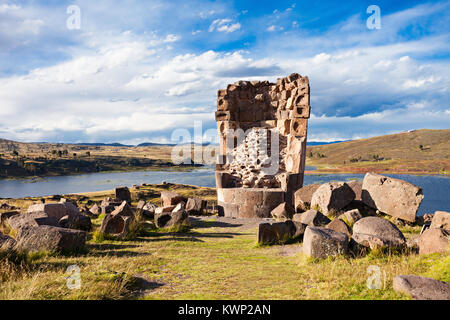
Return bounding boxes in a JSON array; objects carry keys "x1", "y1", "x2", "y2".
[{"x1": 307, "y1": 129, "x2": 450, "y2": 174}]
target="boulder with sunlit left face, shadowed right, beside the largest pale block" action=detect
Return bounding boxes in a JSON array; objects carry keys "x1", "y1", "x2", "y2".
[{"x1": 311, "y1": 182, "x2": 355, "y2": 215}]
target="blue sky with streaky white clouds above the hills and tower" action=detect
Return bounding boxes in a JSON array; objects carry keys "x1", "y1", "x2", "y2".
[{"x1": 0, "y1": 0, "x2": 450, "y2": 144}]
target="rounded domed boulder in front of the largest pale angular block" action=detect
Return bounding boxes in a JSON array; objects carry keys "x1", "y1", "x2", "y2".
[{"x1": 352, "y1": 217, "x2": 406, "y2": 249}]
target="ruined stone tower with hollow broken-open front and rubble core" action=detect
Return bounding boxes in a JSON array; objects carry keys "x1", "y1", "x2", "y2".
[{"x1": 216, "y1": 73, "x2": 311, "y2": 218}]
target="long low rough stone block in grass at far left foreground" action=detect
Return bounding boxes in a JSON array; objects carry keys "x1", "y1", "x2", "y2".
[{"x1": 17, "y1": 226, "x2": 86, "y2": 252}]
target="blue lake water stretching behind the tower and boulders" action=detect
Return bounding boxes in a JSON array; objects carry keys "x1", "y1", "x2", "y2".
[{"x1": 0, "y1": 168, "x2": 450, "y2": 215}]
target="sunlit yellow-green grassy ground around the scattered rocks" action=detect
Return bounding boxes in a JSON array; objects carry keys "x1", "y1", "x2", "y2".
[{"x1": 0, "y1": 185, "x2": 450, "y2": 299}]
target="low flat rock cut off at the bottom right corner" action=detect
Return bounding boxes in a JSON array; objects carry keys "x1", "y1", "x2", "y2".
[{"x1": 393, "y1": 275, "x2": 450, "y2": 300}]
